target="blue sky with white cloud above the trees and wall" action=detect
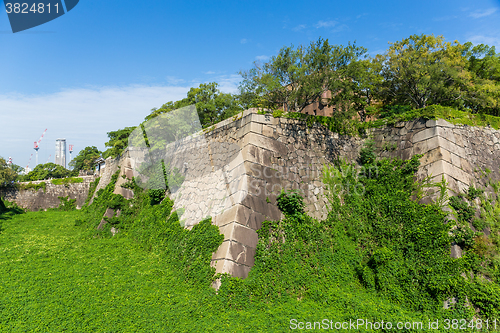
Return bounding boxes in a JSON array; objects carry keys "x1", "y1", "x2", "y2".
[{"x1": 0, "y1": 0, "x2": 500, "y2": 167}]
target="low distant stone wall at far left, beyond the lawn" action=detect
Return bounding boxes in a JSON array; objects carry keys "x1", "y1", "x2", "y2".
[{"x1": 0, "y1": 176, "x2": 95, "y2": 211}]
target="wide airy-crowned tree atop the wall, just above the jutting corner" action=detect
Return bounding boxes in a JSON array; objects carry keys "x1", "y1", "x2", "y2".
[{"x1": 240, "y1": 38, "x2": 366, "y2": 112}]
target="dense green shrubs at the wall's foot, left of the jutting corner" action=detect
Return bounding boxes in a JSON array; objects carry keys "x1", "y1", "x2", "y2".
[{"x1": 76, "y1": 172, "x2": 223, "y2": 284}]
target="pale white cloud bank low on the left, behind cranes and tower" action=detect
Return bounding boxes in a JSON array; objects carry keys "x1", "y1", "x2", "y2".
[{"x1": 0, "y1": 85, "x2": 189, "y2": 167}]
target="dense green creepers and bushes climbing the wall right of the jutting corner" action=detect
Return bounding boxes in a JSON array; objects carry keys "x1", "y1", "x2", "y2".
[{"x1": 219, "y1": 154, "x2": 500, "y2": 321}]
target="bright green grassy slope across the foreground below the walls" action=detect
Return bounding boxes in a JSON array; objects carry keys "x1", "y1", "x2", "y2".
[{"x1": 0, "y1": 211, "x2": 432, "y2": 332}]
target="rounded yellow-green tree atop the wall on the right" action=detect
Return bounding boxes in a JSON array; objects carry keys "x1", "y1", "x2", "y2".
[{"x1": 377, "y1": 34, "x2": 471, "y2": 108}]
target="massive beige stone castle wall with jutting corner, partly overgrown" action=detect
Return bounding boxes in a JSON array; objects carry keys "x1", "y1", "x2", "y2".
[{"x1": 79, "y1": 109, "x2": 500, "y2": 278}]
